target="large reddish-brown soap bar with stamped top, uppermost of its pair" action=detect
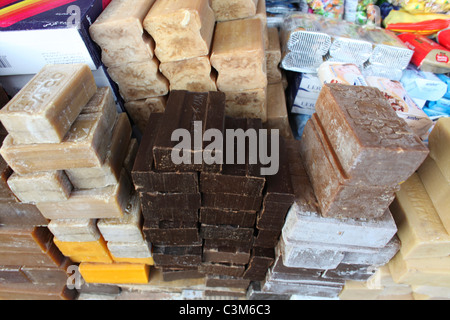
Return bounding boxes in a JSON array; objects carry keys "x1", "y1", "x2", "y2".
[{"x1": 316, "y1": 84, "x2": 429, "y2": 187}]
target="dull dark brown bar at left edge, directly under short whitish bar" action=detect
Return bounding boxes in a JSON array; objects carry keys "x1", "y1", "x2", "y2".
[{"x1": 0, "y1": 201, "x2": 48, "y2": 228}]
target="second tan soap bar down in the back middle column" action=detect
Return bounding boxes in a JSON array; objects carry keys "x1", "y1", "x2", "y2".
[{"x1": 159, "y1": 56, "x2": 217, "y2": 92}]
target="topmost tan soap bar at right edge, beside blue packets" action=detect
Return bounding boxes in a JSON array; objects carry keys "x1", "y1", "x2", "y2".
[{"x1": 428, "y1": 118, "x2": 450, "y2": 183}]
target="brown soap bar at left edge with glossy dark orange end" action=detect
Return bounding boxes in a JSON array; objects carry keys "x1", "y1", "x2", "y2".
[{"x1": 0, "y1": 227, "x2": 53, "y2": 254}]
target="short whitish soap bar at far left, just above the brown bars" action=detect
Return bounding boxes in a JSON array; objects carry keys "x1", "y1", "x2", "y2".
[{"x1": 8, "y1": 170, "x2": 73, "y2": 203}]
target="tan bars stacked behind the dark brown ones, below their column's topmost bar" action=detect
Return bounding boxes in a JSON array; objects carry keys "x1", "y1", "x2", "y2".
[{"x1": 211, "y1": 18, "x2": 267, "y2": 122}]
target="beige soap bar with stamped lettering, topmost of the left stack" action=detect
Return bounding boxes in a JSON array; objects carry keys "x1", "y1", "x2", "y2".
[{"x1": 0, "y1": 64, "x2": 97, "y2": 144}]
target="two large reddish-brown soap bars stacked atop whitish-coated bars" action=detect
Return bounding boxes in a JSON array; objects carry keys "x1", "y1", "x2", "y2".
[{"x1": 301, "y1": 84, "x2": 429, "y2": 219}]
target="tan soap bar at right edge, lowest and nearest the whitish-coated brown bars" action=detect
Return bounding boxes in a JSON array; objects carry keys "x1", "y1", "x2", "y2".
[{"x1": 391, "y1": 174, "x2": 450, "y2": 259}]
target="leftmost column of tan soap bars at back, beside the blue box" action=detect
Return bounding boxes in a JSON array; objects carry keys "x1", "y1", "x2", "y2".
[{"x1": 89, "y1": 0, "x2": 169, "y2": 130}]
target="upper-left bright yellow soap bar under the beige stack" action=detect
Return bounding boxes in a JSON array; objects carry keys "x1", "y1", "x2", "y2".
[{"x1": 53, "y1": 237, "x2": 112, "y2": 263}]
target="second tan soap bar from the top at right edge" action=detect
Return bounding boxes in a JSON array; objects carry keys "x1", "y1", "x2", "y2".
[{"x1": 419, "y1": 158, "x2": 450, "y2": 234}]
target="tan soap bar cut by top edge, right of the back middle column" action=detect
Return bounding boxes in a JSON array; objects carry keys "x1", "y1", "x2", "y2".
[{"x1": 212, "y1": 0, "x2": 258, "y2": 21}]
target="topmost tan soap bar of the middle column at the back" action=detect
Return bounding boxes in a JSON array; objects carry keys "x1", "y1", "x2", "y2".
[{"x1": 144, "y1": 0, "x2": 216, "y2": 62}]
